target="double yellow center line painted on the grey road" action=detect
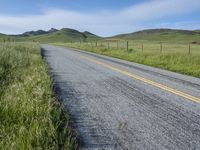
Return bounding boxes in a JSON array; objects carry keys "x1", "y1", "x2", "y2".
[{"x1": 79, "y1": 54, "x2": 200, "y2": 103}]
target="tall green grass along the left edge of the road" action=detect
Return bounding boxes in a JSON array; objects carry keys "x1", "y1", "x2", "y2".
[{"x1": 0, "y1": 43, "x2": 74, "y2": 150}]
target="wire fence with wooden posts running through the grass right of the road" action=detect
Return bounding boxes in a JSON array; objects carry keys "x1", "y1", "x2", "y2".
[{"x1": 67, "y1": 40, "x2": 200, "y2": 55}]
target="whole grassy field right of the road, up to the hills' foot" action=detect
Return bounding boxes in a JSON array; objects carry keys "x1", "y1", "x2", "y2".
[{"x1": 54, "y1": 41, "x2": 200, "y2": 77}]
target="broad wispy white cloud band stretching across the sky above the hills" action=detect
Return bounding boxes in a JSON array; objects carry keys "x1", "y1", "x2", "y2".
[{"x1": 0, "y1": 0, "x2": 200, "y2": 35}]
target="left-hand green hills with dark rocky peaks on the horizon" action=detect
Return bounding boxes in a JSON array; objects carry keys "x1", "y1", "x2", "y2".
[{"x1": 0, "y1": 28, "x2": 101, "y2": 43}]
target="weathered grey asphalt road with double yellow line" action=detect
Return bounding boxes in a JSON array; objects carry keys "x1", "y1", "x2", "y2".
[{"x1": 41, "y1": 45, "x2": 200, "y2": 150}]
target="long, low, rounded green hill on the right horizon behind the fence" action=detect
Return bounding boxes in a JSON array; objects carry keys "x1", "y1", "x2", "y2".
[{"x1": 110, "y1": 29, "x2": 200, "y2": 42}]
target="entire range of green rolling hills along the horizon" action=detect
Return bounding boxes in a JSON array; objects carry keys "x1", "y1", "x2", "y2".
[{"x1": 0, "y1": 28, "x2": 200, "y2": 43}]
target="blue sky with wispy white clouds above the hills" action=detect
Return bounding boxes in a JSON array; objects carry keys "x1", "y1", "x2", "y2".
[{"x1": 0, "y1": 0, "x2": 200, "y2": 36}]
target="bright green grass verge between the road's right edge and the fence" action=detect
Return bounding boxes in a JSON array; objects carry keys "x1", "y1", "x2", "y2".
[{"x1": 54, "y1": 43, "x2": 200, "y2": 78}]
